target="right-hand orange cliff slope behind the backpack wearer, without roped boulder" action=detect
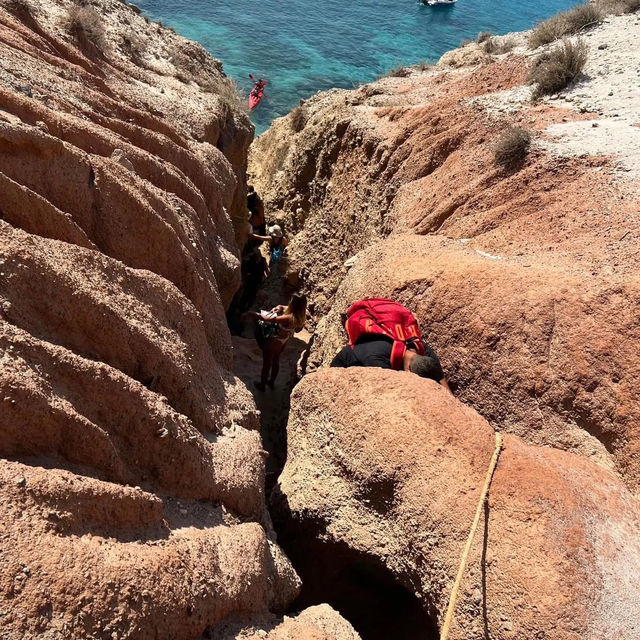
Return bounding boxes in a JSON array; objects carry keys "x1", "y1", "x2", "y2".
[{"x1": 250, "y1": 15, "x2": 640, "y2": 491}]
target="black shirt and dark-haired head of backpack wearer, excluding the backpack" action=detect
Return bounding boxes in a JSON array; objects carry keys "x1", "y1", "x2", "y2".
[{"x1": 331, "y1": 334, "x2": 450, "y2": 390}]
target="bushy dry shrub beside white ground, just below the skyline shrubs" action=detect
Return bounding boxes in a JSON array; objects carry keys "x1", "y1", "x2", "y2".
[{"x1": 529, "y1": 39, "x2": 589, "y2": 100}]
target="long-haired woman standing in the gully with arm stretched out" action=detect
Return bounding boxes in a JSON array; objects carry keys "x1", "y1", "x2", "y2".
[{"x1": 244, "y1": 293, "x2": 307, "y2": 391}]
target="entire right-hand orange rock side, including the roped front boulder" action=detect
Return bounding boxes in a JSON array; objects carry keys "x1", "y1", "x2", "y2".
[{"x1": 250, "y1": 14, "x2": 640, "y2": 640}]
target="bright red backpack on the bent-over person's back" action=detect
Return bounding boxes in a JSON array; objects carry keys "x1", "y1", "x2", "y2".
[{"x1": 344, "y1": 298, "x2": 425, "y2": 370}]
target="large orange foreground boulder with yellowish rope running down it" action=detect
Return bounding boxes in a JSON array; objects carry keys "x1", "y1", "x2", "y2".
[{"x1": 277, "y1": 369, "x2": 640, "y2": 640}]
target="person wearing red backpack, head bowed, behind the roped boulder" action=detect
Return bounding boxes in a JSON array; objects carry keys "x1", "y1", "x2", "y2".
[{"x1": 331, "y1": 298, "x2": 449, "y2": 389}]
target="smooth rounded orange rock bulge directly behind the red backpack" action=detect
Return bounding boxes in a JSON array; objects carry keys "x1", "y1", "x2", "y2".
[{"x1": 311, "y1": 235, "x2": 640, "y2": 488}]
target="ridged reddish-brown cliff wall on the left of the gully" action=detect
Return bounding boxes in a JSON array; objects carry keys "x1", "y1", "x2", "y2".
[{"x1": 0, "y1": 0, "x2": 330, "y2": 640}]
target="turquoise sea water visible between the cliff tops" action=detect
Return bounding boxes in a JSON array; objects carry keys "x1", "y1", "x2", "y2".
[{"x1": 138, "y1": 0, "x2": 576, "y2": 133}]
